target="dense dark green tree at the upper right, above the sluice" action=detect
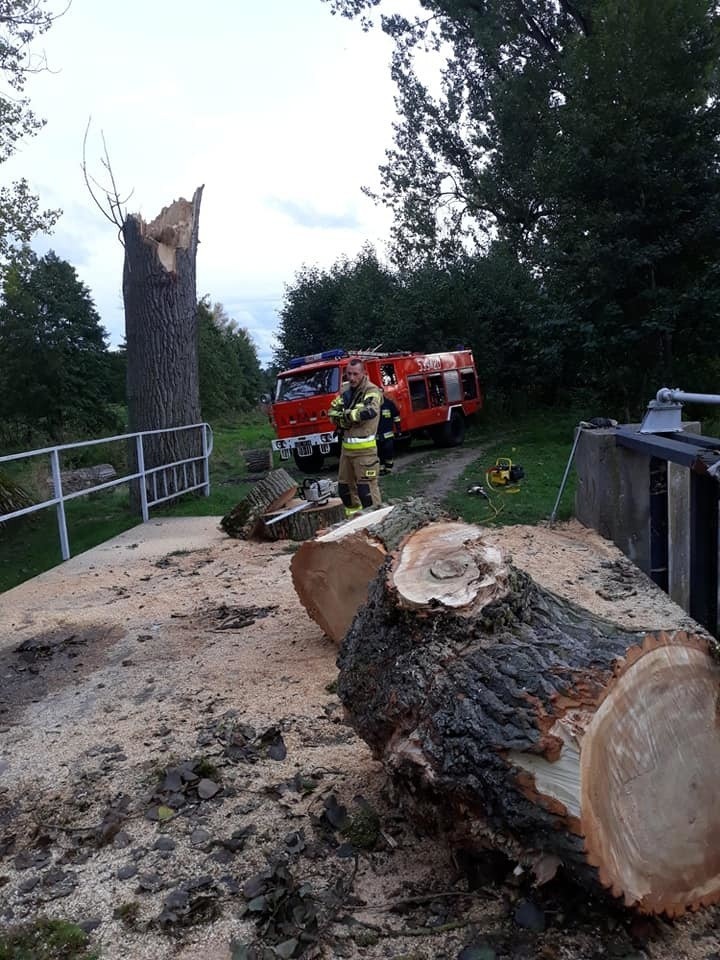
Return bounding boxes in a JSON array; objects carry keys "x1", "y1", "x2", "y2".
[{"x1": 534, "y1": 0, "x2": 720, "y2": 409}]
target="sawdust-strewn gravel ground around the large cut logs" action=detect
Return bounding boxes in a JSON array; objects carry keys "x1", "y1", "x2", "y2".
[{"x1": 0, "y1": 518, "x2": 720, "y2": 960}]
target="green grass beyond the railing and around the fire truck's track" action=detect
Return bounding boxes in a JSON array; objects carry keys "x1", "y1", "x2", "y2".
[{"x1": 0, "y1": 411, "x2": 648, "y2": 592}]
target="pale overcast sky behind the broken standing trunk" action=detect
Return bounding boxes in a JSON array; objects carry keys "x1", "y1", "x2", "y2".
[{"x1": 2, "y1": 0, "x2": 412, "y2": 363}]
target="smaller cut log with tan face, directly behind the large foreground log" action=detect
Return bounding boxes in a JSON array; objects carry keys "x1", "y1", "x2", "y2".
[{"x1": 290, "y1": 499, "x2": 439, "y2": 644}]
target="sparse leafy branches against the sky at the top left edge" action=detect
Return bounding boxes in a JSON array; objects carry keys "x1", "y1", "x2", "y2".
[{"x1": 0, "y1": 0, "x2": 59, "y2": 260}]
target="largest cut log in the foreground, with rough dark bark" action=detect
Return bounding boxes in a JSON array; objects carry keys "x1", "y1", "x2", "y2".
[{"x1": 338, "y1": 522, "x2": 720, "y2": 916}]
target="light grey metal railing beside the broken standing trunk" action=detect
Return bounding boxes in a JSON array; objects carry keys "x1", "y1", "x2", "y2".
[{"x1": 0, "y1": 423, "x2": 213, "y2": 560}]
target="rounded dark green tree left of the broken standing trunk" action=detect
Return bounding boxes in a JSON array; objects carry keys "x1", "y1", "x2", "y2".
[{"x1": 0, "y1": 251, "x2": 115, "y2": 443}]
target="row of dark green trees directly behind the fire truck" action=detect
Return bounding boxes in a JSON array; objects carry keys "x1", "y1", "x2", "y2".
[{"x1": 278, "y1": 242, "x2": 548, "y2": 404}]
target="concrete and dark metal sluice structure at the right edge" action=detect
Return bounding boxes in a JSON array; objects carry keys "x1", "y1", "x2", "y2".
[{"x1": 576, "y1": 387, "x2": 720, "y2": 637}]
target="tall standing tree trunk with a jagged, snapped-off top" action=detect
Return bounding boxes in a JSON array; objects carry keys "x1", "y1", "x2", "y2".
[{"x1": 122, "y1": 187, "x2": 203, "y2": 502}]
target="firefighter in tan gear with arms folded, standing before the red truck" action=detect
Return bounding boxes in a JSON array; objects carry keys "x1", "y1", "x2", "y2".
[{"x1": 328, "y1": 357, "x2": 382, "y2": 517}]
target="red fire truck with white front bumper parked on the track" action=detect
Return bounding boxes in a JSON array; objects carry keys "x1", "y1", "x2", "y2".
[{"x1": 270, "y1": 349, "x2": 482, "y2": 473}]
